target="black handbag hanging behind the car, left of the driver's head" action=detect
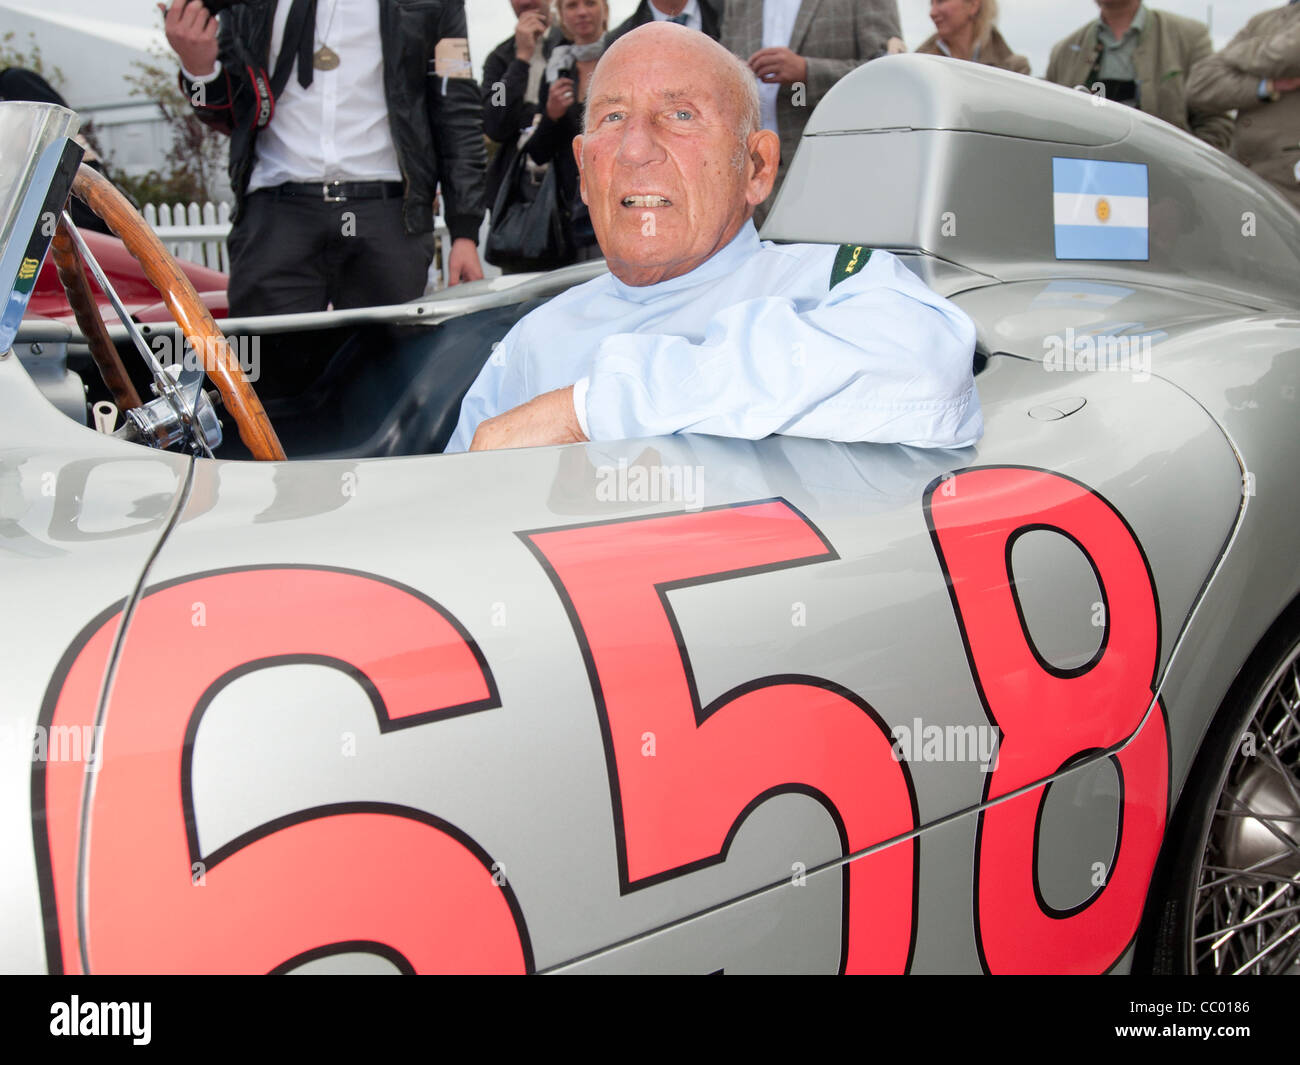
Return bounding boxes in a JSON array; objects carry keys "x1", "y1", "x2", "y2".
[{"x1": 484, "y1": 139, "x2": 573, "y2": 270}]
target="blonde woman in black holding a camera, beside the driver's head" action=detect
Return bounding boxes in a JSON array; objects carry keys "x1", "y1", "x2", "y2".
[{"x1": 525, "y1": 0, "x2": 610, "y2": 259}]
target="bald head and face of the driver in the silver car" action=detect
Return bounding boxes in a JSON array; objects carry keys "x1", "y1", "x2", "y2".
[{"x1": 573, "y1": 36, "x2": 780, "y2": 285}]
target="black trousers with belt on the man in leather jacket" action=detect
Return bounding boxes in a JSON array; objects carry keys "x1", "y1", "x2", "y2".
[{"x1": 228, "y1": 189, "x2": 434, "y2": 317}]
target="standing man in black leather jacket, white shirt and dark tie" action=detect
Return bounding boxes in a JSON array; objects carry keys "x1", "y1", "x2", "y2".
[{"x1": 160, "y1": 0, "x2": 486, "y2": 316}]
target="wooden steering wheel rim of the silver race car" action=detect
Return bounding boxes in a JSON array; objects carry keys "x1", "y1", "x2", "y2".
[{"x1": 51, "y1": 164, "x2": 285, "y2": 459}]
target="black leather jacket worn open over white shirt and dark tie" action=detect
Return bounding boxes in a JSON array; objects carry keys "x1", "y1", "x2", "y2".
[{"x1": 181, "y1": 0, "x2": 488, "y2": 241}]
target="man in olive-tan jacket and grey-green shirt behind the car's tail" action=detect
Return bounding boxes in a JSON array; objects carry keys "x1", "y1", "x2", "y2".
[{"x1": 1045, "y1": 0, "x2": 1232, "y2": 151}]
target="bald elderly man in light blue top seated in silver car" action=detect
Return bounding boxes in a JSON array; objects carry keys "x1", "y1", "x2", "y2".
[{"x1": 447, "y1": 22, "x2": 983, "y2": 451}]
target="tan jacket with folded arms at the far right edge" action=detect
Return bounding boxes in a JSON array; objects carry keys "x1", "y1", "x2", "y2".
[{"x1": 1187, "y1": 4, "x2": 1300, "y2": 207}]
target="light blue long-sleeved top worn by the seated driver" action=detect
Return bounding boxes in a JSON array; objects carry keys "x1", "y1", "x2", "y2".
[{"x1": 446, "y1": 222, "x2": 984, "y2": 453}]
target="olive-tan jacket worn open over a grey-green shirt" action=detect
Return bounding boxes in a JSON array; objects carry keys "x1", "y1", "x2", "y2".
[{"x1": 1047, "y1": 8, "x2": 1232, "y2": 151}]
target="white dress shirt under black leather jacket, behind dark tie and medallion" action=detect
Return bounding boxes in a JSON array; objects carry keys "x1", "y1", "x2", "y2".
[{"x1": 183, "y1": 0, "x2": 402, "y2": 192}]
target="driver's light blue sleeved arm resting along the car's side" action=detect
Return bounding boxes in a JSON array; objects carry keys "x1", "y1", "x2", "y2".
[{"x1": 580, "y1": 254, "x2": 983, "y2": 447}]
